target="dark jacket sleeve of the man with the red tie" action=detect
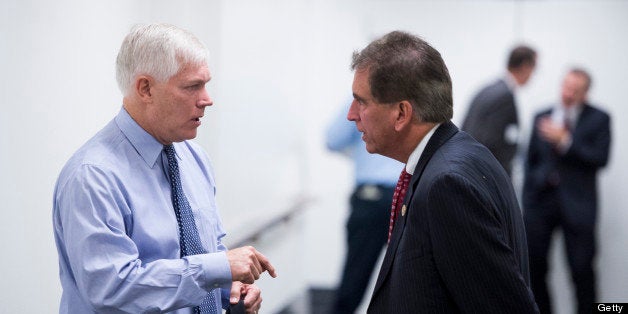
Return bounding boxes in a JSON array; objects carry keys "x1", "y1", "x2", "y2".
[{"x1": 427, "y1": 174, "x2": 538, "y2": 313}]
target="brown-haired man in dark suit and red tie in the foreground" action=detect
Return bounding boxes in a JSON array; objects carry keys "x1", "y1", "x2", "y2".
[{"x1": 347, "y1": 31, "x2": 538, "y2": 313}]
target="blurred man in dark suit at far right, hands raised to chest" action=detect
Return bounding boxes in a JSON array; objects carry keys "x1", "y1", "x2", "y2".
[{"x1": 523, "y1": 69, "x2": 611, "y2": 313}]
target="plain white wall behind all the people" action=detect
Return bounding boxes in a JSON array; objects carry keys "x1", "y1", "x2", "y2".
[{"x1": 0, "y1": 0, "x2": 628, "y2": 313}]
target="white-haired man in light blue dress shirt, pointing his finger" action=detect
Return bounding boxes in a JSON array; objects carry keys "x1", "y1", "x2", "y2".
[{"x1": 53, "y1": 24, "x2": 276, "y2": 313}]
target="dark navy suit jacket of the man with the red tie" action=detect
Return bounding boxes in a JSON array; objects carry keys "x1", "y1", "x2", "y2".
[{"x1": 368, "y1": 122, "x2": 538, "y2": 313}]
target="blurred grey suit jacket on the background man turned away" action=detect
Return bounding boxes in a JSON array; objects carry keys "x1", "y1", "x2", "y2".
[{"x1": 462, "y1": 80, "x2": 519, "y2": 174}]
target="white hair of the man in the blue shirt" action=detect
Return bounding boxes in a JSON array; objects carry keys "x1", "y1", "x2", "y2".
[{"x1": 116, "y1": 24, "x2": 209, "y2": 96}]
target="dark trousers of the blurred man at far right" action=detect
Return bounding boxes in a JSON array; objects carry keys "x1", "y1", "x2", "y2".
[{"x1": 524, "y1": 189, "x2": 596, "y2": 313}]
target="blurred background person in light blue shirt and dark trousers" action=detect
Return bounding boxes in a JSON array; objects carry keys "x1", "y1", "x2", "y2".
[{"x1": 326, "y1": 101, "x2": 403, "y2": 313}]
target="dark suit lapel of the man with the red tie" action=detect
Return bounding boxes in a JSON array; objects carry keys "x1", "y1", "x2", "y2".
[{"x1": 373, "y1": 121, "x2": 458, "y2": 298}]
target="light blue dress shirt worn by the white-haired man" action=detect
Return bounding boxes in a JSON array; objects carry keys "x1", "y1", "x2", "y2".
[{"x1": 53, "y1": 109, "x2": 231, "y2": 313}]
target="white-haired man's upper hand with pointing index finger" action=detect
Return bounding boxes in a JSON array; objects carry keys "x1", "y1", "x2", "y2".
[{"x1": 227, "y1": 246, "x2": 277, "y2": 284}]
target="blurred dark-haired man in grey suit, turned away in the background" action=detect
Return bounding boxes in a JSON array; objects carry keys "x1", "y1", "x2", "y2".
[{"x1": 462, "y1": 46, "x2": 536, "y2": 175}]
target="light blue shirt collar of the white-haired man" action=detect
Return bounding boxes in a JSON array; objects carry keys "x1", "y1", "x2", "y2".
[{"x1": 115, "y1": 107, "x2": 164, "y2": 168}]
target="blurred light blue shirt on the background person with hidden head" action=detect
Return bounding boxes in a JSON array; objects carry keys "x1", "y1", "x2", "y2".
[{"x1": 326, "y1": 103, "x2": 403, "y2": 187}]
